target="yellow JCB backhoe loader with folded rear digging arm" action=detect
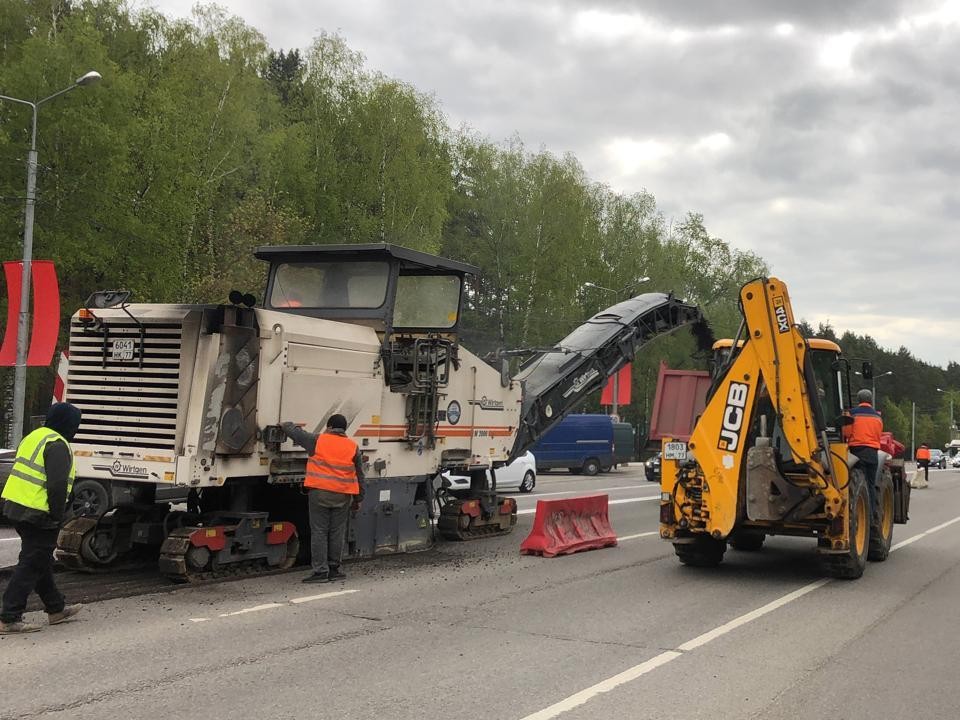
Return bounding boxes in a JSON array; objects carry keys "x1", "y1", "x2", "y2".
[{"x1": 660, "y1": 278, "x2": 910, "y2": 578}]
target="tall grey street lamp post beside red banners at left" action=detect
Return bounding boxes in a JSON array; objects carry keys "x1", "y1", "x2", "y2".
[{"x1": 0, "y1": 70, "x2": 101, "y2": 447}]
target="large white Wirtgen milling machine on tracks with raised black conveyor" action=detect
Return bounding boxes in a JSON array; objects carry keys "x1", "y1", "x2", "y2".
[{"x1": 58, "y1": 244, "x2": 712, "y2": 581}]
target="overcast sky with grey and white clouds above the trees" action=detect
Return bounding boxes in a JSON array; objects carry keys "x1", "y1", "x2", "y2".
[{"x1": 150, "y1": 0, "x2": 960, "y2": 371}]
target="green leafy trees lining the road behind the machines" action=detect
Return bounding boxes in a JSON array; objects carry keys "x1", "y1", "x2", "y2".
[{"x1": 24, "y1": 0, "x2": 960, "y2": 444}]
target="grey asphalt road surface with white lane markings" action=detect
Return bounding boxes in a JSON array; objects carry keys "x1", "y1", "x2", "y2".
[{"x1": 0, "y1": 466, "x2": 960, "y2": 720}]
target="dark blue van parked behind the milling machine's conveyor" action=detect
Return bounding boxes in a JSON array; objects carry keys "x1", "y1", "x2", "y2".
[{"x1": 530, "y1": 415, "x2": 615, "y2": 475}]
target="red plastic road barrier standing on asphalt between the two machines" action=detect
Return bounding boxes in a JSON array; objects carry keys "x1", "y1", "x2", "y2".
[{"x1": 520, "y1": 495, "x2": 617, "y2": 557}]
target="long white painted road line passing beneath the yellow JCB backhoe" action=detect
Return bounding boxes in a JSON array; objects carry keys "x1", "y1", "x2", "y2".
[{"x1": 522, "y1": 517, "x2": 960, "y2": 720}]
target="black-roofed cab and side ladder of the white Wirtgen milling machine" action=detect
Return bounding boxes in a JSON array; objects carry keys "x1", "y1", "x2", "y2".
[{"x1": 255, "y1": 248, "x2": 479, "y2": 448}]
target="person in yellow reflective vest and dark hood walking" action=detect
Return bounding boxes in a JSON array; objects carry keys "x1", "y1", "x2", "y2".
[{"x1": 0, "y1": 403, "x2": 82, "y2": 635}]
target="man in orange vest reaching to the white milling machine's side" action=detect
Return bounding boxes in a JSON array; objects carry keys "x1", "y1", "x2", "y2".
[{"x1": 281, "y1": 413, "x2": 363, "y2": 583}]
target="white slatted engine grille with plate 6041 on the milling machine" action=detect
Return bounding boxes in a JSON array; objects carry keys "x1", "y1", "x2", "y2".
[{"x1": 67, "y1": 319, "x2": 183, "y2": 451}]
